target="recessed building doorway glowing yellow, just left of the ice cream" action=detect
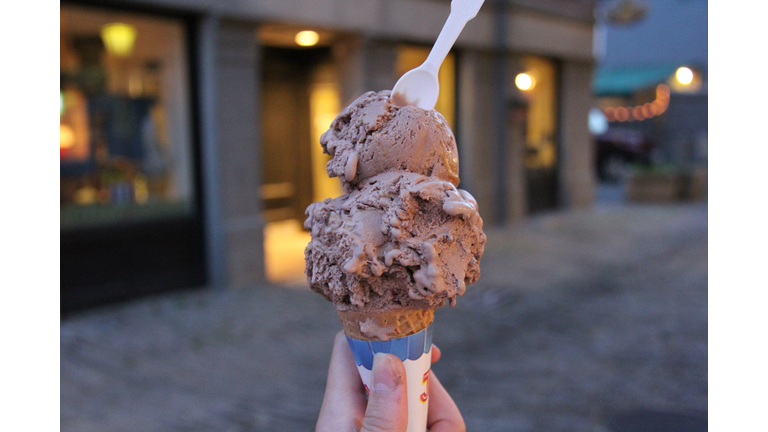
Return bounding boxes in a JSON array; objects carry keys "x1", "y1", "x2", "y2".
[{"x1": 261, "y1": 39, "x2": 342, "y2": 286}]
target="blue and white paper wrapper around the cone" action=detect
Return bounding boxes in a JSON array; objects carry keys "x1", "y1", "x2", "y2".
[{"x1": 347, "y1": 324, "x2": 432, "y2": 432}]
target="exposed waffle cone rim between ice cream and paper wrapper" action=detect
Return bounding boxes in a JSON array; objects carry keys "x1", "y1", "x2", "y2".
[{"x1": 336, "y1": 309, "x2": 435, "y2": 341}]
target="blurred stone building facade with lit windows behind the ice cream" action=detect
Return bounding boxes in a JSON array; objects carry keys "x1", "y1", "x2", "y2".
[{"x1": 60, "y1": 0, "x2": 595, "y2": 311}]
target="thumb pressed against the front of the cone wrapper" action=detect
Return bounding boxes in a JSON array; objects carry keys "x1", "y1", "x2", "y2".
[{"x1": 360, "y1": 353, "x2": 408, "y2": 432}]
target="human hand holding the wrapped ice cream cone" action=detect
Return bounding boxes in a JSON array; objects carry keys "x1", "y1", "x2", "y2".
[{"x1": 315, "y1": 332, "x2": 466, "y2": 432}]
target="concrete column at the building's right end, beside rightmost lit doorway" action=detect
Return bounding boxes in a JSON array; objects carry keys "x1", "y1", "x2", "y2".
[{"x1": 558, "y1": 61, "x2": 595, "y2": 208}]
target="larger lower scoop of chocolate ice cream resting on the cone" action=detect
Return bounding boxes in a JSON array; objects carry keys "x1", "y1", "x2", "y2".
[{"x1": 304, "y1": 172, "x2": 486, "y2": 312}]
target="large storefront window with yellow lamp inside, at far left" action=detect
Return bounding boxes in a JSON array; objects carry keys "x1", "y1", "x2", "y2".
[{"x1": 59, "y1": 6, "x2": 195, "y2": 230}]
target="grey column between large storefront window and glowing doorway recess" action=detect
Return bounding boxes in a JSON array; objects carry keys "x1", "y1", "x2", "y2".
[{"x1": 201, "y1": 18, "x2": 265, "y2": 287}]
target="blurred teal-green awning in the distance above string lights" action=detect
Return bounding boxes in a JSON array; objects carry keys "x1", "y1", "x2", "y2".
[{"x1": 592, "y1": 66, "x2": 676, "y2": 96}]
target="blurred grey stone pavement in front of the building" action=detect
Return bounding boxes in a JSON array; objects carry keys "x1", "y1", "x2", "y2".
[{"x1": 60, "y1": 202, "x2": 708, "y2": 432}]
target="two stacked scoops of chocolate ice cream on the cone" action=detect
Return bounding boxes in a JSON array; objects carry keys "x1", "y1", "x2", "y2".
[{"x1": 304, "y1": 91, "x2": 486, "y2": 320}]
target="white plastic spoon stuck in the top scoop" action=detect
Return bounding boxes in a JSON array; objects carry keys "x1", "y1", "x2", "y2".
[{"x1": 391, "y1": 0, "x2": 485, "y2": 110}]
